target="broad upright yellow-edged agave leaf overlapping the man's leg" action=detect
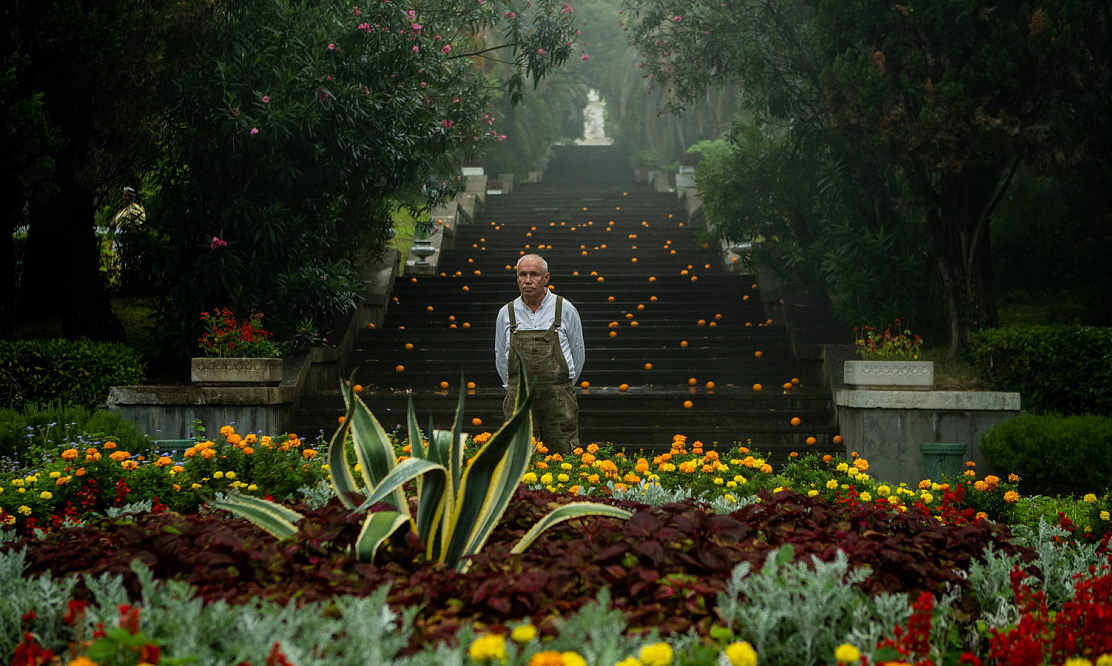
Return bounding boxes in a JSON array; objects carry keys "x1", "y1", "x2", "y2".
[{"x1": 440, "y1": 371, "x2": 534, "y2": 568}]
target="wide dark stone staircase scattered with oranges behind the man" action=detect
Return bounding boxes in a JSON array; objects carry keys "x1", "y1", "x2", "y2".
[{"x1": 296, "y1": 147, "x2": 843, "y2": 461}]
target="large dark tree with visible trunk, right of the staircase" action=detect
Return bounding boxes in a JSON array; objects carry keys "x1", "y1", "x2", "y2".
[{"x1": 626, "y1": 0, "x2": 1106, "y2": 350}]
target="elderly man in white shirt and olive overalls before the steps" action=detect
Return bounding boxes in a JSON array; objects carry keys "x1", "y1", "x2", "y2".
[{"x1": 494, "y1": 255, "x2": 584, "y2": 455}]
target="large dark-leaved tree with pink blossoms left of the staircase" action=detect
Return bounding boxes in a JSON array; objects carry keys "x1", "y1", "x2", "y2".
[{"x1": 140, "y1": 0, "x2": 575, "y2": 354}]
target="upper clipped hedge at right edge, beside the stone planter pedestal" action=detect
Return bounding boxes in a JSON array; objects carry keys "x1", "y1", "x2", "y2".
[{"x1": 971, "y1": 325, "x2": 1112, "y2": 415}]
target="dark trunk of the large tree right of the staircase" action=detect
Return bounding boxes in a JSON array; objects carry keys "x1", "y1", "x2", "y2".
[{"x1": 913, "y1": 168, "x2": 1007, "y2": 356}]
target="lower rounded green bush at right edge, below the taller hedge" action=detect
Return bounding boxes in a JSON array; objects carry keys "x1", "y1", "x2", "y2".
[{"x1": 981, "y1": 414, "x2": 1112, "y2": 495}]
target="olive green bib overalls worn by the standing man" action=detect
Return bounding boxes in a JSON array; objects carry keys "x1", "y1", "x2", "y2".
[{"x1": 502, "y1": 296, "x2": 579, "y2": 456}]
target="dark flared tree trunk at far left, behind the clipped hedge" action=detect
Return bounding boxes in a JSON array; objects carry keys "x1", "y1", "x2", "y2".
[{"x1": 19, "y1": 185, "x2": 123, "y2": 341}]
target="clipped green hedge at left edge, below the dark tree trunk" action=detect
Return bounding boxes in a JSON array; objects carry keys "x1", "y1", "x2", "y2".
[{"x1": 0, "y1": 339, "x2": 143, "y2": 409}]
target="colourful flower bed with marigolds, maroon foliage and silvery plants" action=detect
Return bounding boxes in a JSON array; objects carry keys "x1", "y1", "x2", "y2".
[{"x1": 0, "y1": 427, "x2": 1112, "y2": 666}]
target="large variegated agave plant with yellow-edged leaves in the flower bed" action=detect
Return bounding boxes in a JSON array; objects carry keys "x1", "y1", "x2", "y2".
[{"x1": 209, "y1": 364, "x2": 631, "y2": 571}]
